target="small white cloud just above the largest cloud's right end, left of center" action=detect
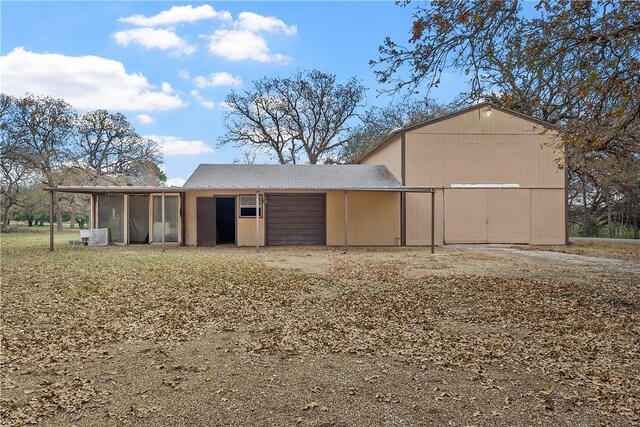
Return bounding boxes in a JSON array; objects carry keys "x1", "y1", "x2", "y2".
[{"x1": 113, "y1": 27, "x2": 196, "y2": 55}]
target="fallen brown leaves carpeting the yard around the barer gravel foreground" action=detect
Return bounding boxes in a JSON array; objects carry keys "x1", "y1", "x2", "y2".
[{"x1": 0, "y1": 242, "x2": 640, "y2": 424}]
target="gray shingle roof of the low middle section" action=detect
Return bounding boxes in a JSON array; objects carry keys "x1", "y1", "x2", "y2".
[{"x1": 183, "y1": 164, "x2": 402, "y2": 190}]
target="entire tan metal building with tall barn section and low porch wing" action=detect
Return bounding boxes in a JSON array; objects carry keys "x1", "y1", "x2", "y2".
[{"x1": 49, "y1": 103, "x2": 567, "y2": 251}]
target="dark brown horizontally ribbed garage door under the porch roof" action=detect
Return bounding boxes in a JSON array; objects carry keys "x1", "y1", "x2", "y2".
[{"x1": 266, "y1": 194, "x2": 326, "y2": 246}]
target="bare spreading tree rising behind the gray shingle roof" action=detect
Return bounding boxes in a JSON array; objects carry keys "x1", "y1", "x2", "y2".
[{"x1": 219, "y1": 70, "x2": 365, "y2": 164}]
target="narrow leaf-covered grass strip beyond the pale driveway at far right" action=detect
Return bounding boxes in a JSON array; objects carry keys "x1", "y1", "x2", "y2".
[{"x1": 514, "y1": 240, "x2": 640, "y2": 261}]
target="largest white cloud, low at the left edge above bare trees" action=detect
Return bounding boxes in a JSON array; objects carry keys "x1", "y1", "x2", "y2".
[{"x1": 0, "y1": 47, "x2": 186, "y2": 111}]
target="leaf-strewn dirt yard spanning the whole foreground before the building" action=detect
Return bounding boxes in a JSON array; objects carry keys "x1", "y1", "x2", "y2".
[{"x1": 0, "y1": 239, "x2": 640, "y2": 426}]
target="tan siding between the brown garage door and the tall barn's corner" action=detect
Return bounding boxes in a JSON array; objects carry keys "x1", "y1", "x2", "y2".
[{"x1": 327, "y1": 191, "x2": 400, "y2": 246}]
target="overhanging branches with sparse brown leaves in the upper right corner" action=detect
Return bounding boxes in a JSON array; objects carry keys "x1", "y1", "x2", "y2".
[{"x1": 372, "y1": 0, "x2": 640, "y2": 152}]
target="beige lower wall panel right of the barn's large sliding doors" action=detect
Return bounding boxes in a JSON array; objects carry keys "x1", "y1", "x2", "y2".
[{"x1": 529, "y1": 190, "x2": 565, "y2": 245}]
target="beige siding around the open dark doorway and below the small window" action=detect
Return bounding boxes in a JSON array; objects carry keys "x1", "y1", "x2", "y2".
[{"x1": 185, "y1": 191, "x2": 264, "y2": 246}]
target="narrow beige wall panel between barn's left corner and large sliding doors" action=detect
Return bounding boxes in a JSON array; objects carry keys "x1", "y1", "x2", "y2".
[{"x1": 407, "y1": 190, "x2": 444, "y2": 246}]
